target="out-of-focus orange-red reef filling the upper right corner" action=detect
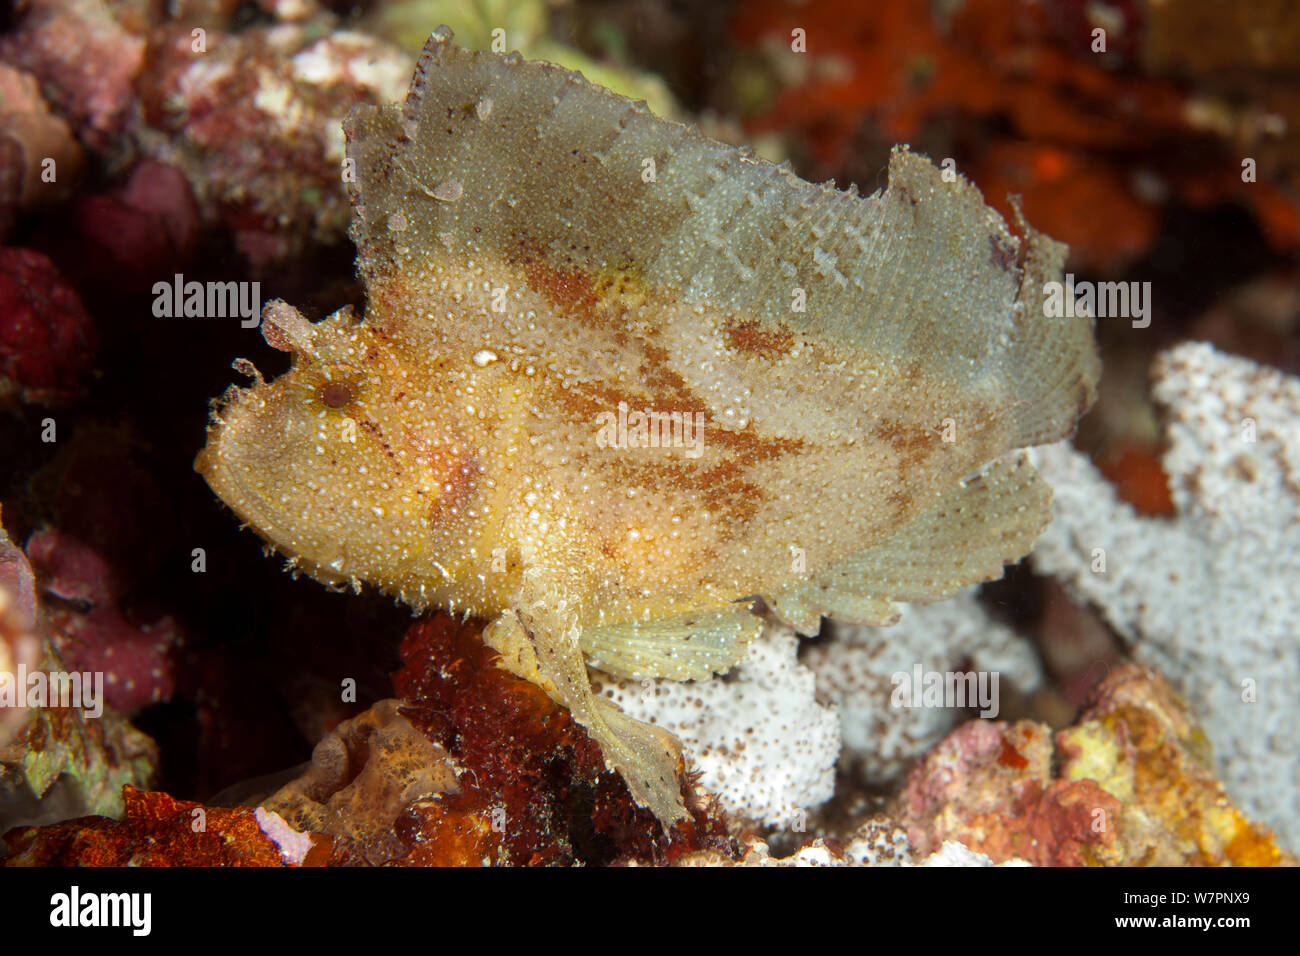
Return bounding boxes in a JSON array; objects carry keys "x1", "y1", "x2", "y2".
[{"x1": 733, "y1": 0, "x2": 1300, "y2": 272}]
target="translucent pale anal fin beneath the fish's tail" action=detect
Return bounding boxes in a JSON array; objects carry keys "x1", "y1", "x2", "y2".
[{"x1": 766, "y1": 453, "x2": 1052, "y2": 633}]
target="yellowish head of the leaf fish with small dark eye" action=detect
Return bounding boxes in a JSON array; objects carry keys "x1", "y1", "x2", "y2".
[{"x1": 194, "y1": 302, "x2": 475, "y2": 595}]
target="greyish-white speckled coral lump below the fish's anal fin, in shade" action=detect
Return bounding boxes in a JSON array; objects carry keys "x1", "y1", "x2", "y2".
[{"x1": 803, "y1": 588, "x2": 1043, "y2": 783}]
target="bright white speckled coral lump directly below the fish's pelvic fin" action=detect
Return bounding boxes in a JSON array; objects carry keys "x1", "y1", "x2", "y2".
[{"x1": 595, "y1": 623, "x2": 840, "y2": 830}]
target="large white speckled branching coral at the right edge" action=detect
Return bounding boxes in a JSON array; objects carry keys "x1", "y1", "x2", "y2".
[{"x1": 1034, "y1": 343, "x2": 1300, "y2": 849}]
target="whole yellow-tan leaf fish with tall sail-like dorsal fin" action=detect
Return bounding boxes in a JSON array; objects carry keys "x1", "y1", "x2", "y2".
[{"x1": 196, "y1": 29, "x2": 1099, "y2": 822}]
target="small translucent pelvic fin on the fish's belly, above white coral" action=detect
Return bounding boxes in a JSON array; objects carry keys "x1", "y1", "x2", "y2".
[{"x1": 582, "y1": 604, "x2": 763, "y2": 680}]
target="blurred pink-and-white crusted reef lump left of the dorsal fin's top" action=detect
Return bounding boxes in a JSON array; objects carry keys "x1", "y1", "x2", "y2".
[{"x1": 137, "y1": 26, "x2": 411, "y2": 273}]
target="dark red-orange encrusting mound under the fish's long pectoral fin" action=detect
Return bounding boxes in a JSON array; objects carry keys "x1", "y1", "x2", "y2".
[{"x1": 393, "y1": 614, "x2": 732, "y2": 865}]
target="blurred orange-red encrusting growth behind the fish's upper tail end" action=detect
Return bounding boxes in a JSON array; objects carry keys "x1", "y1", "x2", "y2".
[{"x1": 732, "y1": 0, "x2": 1300, "y2": 271}]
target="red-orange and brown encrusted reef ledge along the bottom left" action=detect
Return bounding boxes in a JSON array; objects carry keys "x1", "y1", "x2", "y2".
[{"x1": 7, "y1": 615, "x2": 736, "y2": 866}]
